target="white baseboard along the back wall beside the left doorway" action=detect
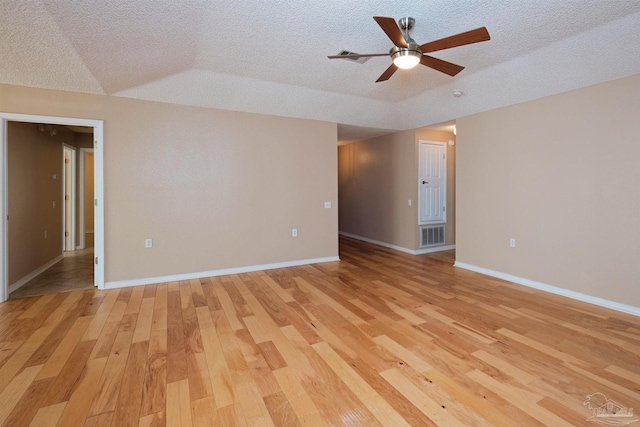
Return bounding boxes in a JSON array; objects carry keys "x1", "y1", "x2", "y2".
[{"x1": 104, "y1": 256, "x2": 340, "y2": 289}]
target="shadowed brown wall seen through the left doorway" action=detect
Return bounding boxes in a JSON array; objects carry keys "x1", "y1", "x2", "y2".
[{"x1": 7, "y1": 122, "x2": 73, "y2": 284}]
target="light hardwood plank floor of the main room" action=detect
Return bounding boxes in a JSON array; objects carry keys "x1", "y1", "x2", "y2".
[{"x1": 0, "y1": 239, "x2": 640, "y2": 427}]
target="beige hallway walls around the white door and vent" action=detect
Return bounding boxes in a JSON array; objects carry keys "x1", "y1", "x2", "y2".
[{"x1": 338, "y1": 130, "x2": 455, "y2": 250}]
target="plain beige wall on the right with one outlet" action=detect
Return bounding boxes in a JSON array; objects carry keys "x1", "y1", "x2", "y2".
[{"x1": 456, "y1": 75, "x2": 640, "y2": 307}]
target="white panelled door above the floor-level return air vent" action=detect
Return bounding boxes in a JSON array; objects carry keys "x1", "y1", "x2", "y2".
[{"x1": 418, "y1": 141, "x2": 447, "y2": 224}]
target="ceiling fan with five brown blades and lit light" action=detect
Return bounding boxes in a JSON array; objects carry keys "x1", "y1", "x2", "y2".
[{"x1": 328, "y1": 16, "x2": 491, "y2": 83}]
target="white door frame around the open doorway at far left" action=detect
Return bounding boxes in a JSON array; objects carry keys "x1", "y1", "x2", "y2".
[{"x1": 0, "y1": 112, "x2": 105, "y2": 302}]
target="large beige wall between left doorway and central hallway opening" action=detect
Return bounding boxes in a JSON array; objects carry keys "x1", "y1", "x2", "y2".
[{"x1": 0, "y1": 86, "x2": 338, "y2": 282}]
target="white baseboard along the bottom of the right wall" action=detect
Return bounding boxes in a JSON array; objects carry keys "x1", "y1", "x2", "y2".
[{"x1": 453, "y1": 261, "x2": 640, "y2": 316}]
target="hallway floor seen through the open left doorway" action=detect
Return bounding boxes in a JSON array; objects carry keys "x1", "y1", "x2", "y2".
[{"x1": 9, "y1": 233, "x2": 94, "y2": 299}]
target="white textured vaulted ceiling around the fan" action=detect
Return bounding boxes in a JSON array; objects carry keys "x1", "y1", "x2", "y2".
[{"x1": 0, "y1": 0, "x2": 640, "y2": 140}]
